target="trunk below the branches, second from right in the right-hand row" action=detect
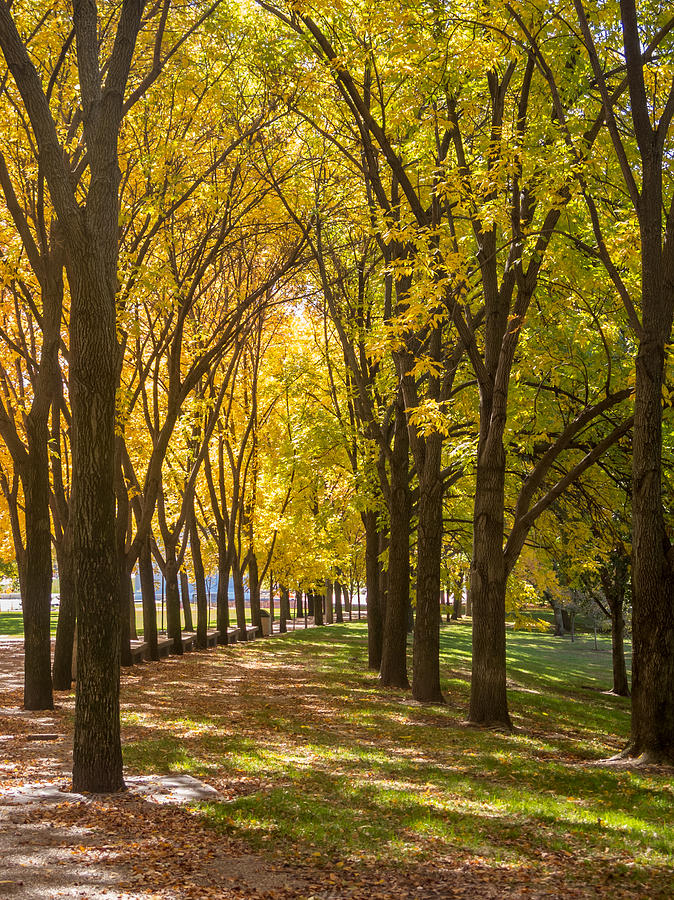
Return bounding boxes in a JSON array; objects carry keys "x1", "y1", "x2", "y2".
[{"x1": 469, "y1": 430, "x2": 512, "y2": 728}]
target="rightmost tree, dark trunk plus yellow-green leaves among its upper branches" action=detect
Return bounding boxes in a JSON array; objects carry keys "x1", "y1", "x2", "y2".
[{"x1": 520, "y1": 0, "x2": 674, "y2": 761}]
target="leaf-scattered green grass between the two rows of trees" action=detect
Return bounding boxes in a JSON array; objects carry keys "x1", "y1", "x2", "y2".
[{"x1": 114, "y1": 623, "x2": 674, "y2": 896}]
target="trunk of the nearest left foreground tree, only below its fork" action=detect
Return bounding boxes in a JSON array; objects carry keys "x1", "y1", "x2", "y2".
[{"x1": 68, "y1": 250, "x2": 123, "y2": 792}]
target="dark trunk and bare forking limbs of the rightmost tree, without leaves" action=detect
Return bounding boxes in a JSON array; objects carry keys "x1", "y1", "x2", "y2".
[{"x1": 574, "y1": 0, "x2": 674, "y2": 761}]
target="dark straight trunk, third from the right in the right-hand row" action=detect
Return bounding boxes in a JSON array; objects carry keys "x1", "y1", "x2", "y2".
[{"x1": 412, "y1": 433, "x2": 445, "y2": 703}]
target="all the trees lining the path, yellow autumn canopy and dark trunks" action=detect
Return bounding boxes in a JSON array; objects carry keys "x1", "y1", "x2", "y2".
[{"x1": 0, "y1": 0, "x2": 674, "y2": 790}]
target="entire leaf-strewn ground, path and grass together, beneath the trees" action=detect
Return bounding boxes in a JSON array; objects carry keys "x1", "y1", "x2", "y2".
[{"x1": 0, "y1": 623, "x2": 674, "y2": 900}]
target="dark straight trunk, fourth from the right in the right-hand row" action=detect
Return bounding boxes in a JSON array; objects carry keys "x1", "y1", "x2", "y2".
[{"x1": 379, "y1": 396, "x2": 411, "y2": 688}]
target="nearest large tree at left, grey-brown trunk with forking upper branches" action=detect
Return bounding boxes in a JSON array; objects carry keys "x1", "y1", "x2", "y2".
[{"x1": 0, "y1": 0, "x2": 223, "y2": 791}]
